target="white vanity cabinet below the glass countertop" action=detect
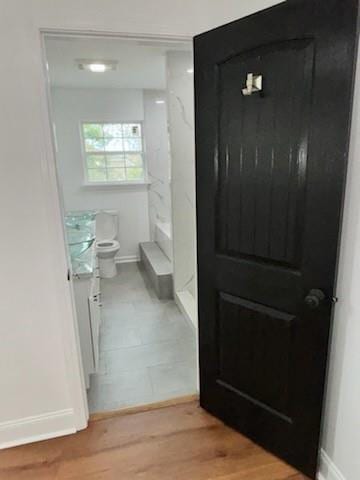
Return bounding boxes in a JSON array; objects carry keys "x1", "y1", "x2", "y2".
[{"x1": 73, "y1": 255, "x2": 101, "y2": 388}]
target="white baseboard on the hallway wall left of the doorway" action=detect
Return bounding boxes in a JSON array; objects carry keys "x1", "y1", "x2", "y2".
[{"x1": 0, "y1": 408, "x2": 76, "y2": 449}]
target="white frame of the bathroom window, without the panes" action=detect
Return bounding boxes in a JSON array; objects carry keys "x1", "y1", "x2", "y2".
[{"x1": 79, "y1": 120, "x2": 150, "y2": 188}]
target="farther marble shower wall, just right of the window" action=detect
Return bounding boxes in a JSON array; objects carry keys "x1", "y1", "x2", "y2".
[{"x1": 144, "y1": 90, "x2": 171, "y2": 240}]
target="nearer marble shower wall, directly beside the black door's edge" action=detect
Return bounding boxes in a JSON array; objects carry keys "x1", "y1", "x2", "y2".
[{"x1": 166, "y1": 51, "x2": 196, "y2": 298}]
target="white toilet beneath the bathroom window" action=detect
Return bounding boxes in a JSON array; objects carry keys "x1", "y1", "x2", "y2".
[{"x1": 96, "y1": 210, "x2": 120, "y2": 278}]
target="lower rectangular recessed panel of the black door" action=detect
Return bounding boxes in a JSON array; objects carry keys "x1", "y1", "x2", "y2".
[{"x1": 217, "y1": 293, "x2": 295, "y2": 421}]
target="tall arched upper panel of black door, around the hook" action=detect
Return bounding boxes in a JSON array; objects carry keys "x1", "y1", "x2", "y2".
[{"x1": 217, "y1": 40, "x2": 314, "y2": 266}]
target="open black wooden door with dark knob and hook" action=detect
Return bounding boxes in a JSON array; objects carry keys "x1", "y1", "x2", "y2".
[{"x1": 195, "y1": 0, "x2": 358, "y2": 477}]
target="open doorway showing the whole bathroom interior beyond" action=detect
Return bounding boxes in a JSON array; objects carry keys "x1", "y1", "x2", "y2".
[{"x1": 44, "y1": 34, "x2": 198, "y2": 413}]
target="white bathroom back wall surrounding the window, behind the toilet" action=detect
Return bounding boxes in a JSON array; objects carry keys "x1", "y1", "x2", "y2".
[{"x1": 51, "y1": 88, "x2": 149, "y2": 259}]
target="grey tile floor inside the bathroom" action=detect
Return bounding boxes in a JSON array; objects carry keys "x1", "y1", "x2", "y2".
[{"x1": 88, "y1": 263, "x2": 197, "y2": 413}]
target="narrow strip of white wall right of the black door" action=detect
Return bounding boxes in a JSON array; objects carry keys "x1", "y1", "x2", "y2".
[{"x1": 321, "y1": 49, "x2": 360, "y2": 480}]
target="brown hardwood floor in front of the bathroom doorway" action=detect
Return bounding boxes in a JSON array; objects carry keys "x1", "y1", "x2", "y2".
[{"x1": 0, "y1": 402, "x2": 306, "y2": 480}]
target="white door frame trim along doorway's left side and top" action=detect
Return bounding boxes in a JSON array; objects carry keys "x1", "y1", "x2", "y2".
[{"x1": 40, "y1": 28, "x2": 192, "y2": 430}]
